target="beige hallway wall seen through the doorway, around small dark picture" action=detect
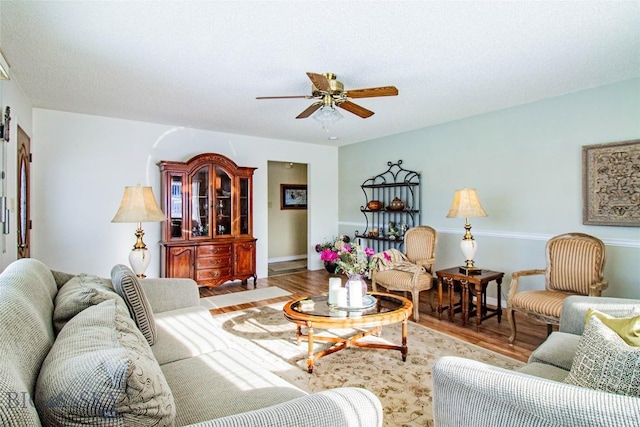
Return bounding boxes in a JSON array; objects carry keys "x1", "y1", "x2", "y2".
[{"x1": 268, "y1": 162, "x2": 310, "y2": 262}]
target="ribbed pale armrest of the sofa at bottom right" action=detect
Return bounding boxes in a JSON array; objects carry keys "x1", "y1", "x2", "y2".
[{"x1": 432, "y1": 356, "x2": 640, "y2": 427}]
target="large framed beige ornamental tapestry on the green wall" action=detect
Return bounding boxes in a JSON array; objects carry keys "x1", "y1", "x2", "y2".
[{"x1": 582, "y1": 139, "x2": 640, "y2": 227}]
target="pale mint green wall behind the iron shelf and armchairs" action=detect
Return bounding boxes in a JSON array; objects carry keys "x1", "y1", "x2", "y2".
[{"x1": 339, "y1": 79, "x2": 640, "y2": 298}]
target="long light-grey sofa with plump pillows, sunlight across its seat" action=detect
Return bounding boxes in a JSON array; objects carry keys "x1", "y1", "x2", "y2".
[{"x1": 0, "y1": 259, "x2": 382, "y2": 427}]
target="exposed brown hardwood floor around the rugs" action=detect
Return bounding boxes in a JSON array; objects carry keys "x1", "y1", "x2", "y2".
[{"x1": 200, "y1": 270, "x2": 546, "y2": 362}]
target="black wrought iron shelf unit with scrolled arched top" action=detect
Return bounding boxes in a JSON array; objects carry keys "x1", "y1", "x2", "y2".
[{"x1": 355, "y1": 160, "x2": 421, "y2": 252}]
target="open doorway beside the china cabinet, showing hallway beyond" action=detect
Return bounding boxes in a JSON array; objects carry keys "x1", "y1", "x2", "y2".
[{"x1": 267, "y1": 161, "x2": 308, "y2": 276}]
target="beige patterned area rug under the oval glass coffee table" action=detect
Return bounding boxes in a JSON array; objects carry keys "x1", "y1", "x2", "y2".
[{"x1": 214, "y1": 303, "x2": 523, "y2": 427}]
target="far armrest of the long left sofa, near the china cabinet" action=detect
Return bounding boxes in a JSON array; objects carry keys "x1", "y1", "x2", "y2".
[{"x1": 140, "y1": 279, "x2": 200, "y2": 313}]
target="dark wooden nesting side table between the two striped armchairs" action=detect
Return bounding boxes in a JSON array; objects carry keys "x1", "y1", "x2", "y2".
[{"x1": 436, "y1": 267, "x2": 504, "y2": 332}]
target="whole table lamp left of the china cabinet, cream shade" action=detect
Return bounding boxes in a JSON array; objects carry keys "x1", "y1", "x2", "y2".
[{"x1": 111, "y1": 184, "x2": 166, "y2": 279}]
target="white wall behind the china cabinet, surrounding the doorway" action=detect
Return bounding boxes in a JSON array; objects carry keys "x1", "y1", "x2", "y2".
[{"x1": 32, "y1": 109, "x2": 338, "y2": 277}]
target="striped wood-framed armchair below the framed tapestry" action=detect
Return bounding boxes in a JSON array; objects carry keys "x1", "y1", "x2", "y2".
[{"x1": 507, "y1": 233, "x2": 608, "y2": 344}]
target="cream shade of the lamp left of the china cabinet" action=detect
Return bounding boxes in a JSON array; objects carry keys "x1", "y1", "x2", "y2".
[{"x1": 111, "y1": 184, "x2": 166, "y2": 222}]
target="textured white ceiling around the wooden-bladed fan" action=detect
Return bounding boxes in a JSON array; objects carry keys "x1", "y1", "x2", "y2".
[{"x1": 0, "y1": 0, "x2": 640, "y2": 145}]
